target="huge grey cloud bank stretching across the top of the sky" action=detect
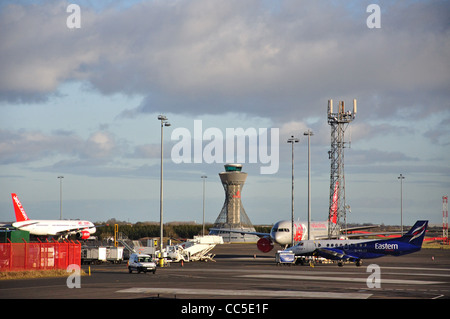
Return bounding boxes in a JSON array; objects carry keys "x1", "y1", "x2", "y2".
[{"x1": 0, "y1": 0, "x2": 450, "y2": 120}]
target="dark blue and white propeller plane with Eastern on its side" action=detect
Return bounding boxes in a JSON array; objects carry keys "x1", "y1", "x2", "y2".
[{"x1": 286, "y1": 220, "x2": 428, "y2": 266}]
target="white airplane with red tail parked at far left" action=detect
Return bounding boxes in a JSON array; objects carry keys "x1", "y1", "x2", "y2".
[{"x1": 11, "y1": 193, "x2": 96, "y2": 239}]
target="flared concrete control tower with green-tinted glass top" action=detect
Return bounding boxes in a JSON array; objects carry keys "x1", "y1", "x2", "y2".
[{"x1": 210, "y1": 164, "x2": 258, "y2": 242}]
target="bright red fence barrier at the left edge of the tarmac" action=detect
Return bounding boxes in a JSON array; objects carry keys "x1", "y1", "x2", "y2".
[{"x1": 0, "y1": 241, "x2": 81, "y2": 271}]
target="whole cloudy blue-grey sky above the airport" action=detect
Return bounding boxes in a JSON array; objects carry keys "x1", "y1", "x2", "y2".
[{"x1": 0, "y1": 0, "x2": 450, "y2": 225}]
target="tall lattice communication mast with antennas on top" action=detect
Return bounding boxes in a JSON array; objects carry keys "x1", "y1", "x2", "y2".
[{"x1": 328, "y1": 99, "x2": 356, "y2": 238}]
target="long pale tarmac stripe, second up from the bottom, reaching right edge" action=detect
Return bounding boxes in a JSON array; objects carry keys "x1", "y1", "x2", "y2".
[{"x1": 241, "y1": 274, "x2": 445, "y2": 285}]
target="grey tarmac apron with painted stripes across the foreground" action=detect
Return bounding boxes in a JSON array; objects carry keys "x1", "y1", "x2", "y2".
[{"x1": 0, "y1": 244, "x2": 450, "y2": 299}]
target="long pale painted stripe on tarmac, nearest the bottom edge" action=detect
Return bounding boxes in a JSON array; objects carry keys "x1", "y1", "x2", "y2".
[{"x1": 117, "y1": 288, "x2": 372, "y2": 299}]
